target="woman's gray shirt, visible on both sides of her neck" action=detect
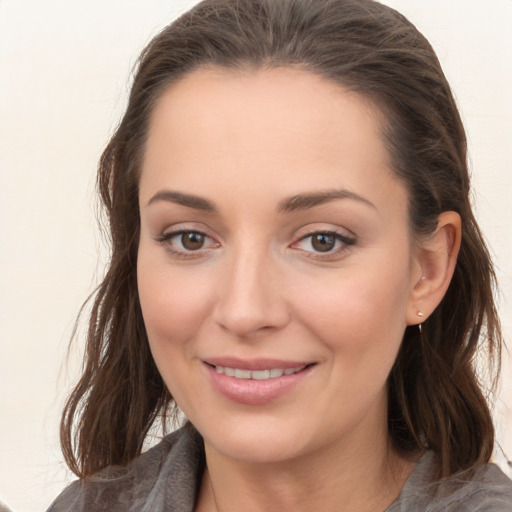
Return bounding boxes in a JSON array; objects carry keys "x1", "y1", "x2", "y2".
[{"x1": 47, "y1": 424, "x2": 512, "y2": 512}]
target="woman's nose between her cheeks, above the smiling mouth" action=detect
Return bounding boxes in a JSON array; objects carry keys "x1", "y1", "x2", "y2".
[{"x1": 214, "y1": 245, "x2": 290, "y2": 338}]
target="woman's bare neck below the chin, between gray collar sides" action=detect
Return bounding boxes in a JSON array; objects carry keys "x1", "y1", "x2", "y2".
[{"x1": 196, "y1": 414, "x2": 414, "y2": 512}]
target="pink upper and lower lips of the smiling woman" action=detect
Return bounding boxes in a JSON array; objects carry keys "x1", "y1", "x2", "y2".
[{"x1": 203, "y1": 357, "x2": 315, "y2": 406}]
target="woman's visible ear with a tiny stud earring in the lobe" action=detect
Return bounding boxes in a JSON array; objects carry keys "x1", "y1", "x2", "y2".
[{"x1": 406, "y1": 212, "x2": 462, "y2": 325}]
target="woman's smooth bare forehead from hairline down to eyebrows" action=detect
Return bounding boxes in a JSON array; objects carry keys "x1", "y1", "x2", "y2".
[{"x1": 141, "y1": 68, "x2": 404, "y2": 217}]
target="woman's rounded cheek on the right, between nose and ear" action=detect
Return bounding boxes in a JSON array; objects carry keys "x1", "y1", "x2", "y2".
[{"x1": 296, "y1": 256, "x2": 409, "y2": 356}]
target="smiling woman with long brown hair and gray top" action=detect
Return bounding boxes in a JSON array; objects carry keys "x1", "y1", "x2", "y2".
[{"x1": 46, "y1": 0, "x2": 512, "y2": 512}]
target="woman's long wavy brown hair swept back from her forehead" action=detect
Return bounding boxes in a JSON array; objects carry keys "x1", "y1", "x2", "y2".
[{"x1": 61, "y1": 0, "x2": 501, "y2": 477}]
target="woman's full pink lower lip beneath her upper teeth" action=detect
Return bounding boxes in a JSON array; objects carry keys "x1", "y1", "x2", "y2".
[{"x1": 205, "y1": 363, "x2": 313, "y2": 405}]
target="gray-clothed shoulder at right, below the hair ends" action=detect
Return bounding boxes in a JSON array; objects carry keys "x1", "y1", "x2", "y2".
[{"x1": 386, "y1": 453, "x2": 512, "y2": 512}]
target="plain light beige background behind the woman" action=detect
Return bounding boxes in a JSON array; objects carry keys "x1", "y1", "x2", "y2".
[{"x1": 0, "y1": 0, "x2": 512, "y2": 512}]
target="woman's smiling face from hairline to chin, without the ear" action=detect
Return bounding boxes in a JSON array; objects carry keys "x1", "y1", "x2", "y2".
[{"x1": 138, "y1": 69, "x2": 421, "y2": 461}]
